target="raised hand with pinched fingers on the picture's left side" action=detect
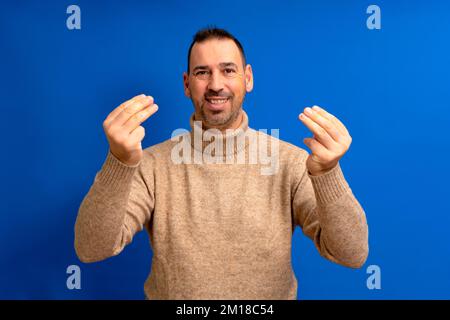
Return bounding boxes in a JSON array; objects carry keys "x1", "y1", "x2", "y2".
[{"x1": 103, "y1": 94, "x2": 158, "y2": 166}]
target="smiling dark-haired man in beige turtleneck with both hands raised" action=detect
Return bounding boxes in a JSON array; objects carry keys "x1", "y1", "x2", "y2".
[{"x1": 75, "y1": 28, "x2": 368, "y2": 299}]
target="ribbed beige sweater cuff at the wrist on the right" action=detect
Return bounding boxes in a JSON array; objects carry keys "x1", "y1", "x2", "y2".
[{"x1": 308, "y1": 162, "x2": 351, "y2": 206}]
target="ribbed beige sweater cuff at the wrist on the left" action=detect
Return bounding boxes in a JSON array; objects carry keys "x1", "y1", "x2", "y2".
[{"x1": 97, "y1": 151, "x2": 139, "y2": 191}]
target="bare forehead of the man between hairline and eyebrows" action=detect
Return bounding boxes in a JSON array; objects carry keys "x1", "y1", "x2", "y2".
[{"x1": 190, "y1": 39, "x2": 243, "y2": 67}]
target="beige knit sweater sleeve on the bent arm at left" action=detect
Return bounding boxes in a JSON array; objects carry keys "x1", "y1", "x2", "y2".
[{"x1": 75, "y1": 151, "x2": 154, "y2": 262}]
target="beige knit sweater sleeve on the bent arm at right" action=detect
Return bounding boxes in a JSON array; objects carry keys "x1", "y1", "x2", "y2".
[{"x1": 293, "y1": 151, "x2": 369, "y2": 268}]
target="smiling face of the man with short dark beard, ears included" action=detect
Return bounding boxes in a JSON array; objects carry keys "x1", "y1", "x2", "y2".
[{"x1": 183, "y1": 39, "x2": 253, "y2": 130}]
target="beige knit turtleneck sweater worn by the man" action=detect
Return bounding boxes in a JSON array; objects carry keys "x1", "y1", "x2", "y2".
[{"x1": 75, "y1": 112, "x2": 368, "y2": 299}]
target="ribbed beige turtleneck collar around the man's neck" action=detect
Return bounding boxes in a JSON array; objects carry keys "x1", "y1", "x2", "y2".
[{"x1": 189, "y1": 109, "x2": 249, "y2": 157}]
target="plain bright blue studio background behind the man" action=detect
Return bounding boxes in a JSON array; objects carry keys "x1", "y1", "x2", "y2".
[{"x1": 0, "y1": 1, "x2": 450, "y2": 299}]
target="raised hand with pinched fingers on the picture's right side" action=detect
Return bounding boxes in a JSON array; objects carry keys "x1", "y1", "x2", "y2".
[{"x1": 299, "y1": 106, "x2": 352, "y2": 176}]
